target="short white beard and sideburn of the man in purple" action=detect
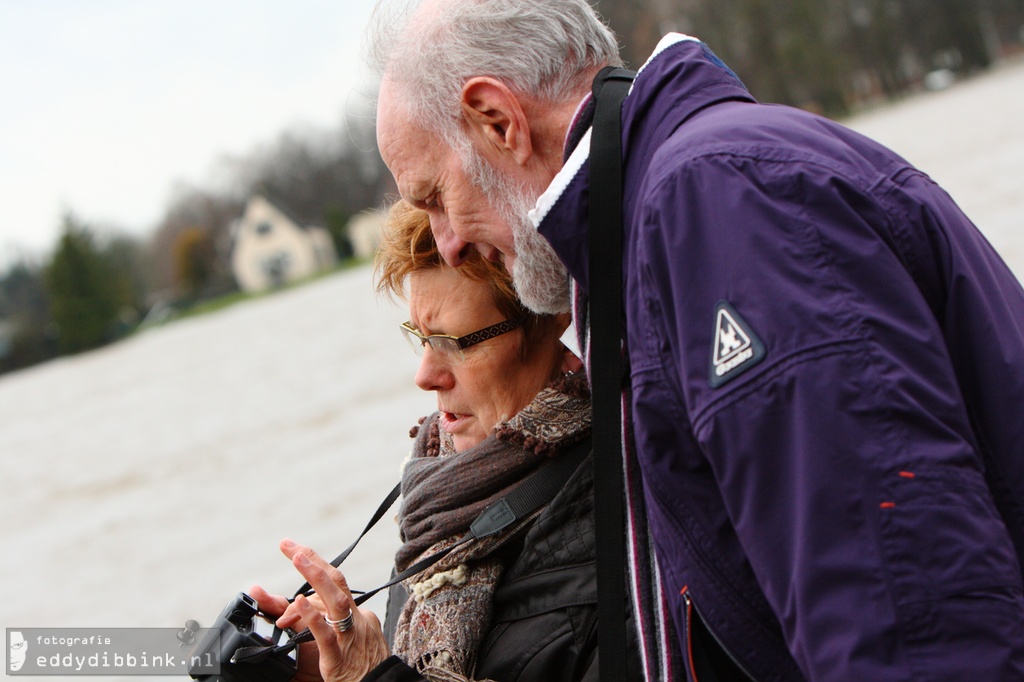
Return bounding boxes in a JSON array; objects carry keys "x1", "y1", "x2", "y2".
[{"x1": 463, "y1": 147, "x2": 572, "y2": 314}]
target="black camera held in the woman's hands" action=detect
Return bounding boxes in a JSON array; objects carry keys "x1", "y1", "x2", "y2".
[{"x1": 188, "y1": 592, "x2": 295, "y2": 682}]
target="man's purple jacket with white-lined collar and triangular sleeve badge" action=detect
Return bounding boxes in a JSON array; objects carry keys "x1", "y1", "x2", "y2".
[{"x1": 534, "y1": 36, "x2": 1024, "y2": 682}]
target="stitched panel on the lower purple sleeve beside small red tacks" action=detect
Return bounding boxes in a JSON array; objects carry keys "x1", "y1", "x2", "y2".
[{"x1": 879, "y1": 464, "x2": 1024, "y2": 680}]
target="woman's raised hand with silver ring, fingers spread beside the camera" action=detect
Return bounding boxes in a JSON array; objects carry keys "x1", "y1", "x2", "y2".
[{"x1": 262, "y1": 539, "x2": 388, "y2": 682}]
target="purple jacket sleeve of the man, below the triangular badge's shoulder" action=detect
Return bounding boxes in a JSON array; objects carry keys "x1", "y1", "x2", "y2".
[{"x1": 629, "y1": 154, "x2": 1024, "y2": 681}]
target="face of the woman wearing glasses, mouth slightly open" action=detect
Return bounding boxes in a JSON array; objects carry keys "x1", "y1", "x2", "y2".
[{"x1": 409, "y1": 266, "x2": 562, "y2": 452}]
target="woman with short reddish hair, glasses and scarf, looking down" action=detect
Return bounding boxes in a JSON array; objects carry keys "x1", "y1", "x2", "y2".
[{"x1": 252, "y1": 203, "x2": 610, "y2": 682}]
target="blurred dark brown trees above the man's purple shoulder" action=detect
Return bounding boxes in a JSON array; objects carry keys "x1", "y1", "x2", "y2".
[{"x1": 598, "y1": 0, "x2": 1024, "y2": 118}]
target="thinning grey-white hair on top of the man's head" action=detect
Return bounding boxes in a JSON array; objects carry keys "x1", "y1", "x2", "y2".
[{"x1": 368, "y1": 0, "x2": 622, "y2": 146}]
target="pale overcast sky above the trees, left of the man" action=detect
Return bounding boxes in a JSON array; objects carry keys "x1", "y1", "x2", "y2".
[{"x1": 0, "y1": 0, "x2": 373, "y2": 265}]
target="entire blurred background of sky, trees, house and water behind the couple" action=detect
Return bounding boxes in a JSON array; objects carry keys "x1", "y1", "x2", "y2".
[{"x1": 0, "y1": 0, "x2": 1024, "y2": 675}]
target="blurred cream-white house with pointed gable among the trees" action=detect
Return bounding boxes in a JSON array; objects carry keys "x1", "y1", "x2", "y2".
[{"x1": 231, "y1": 195, "x2": 338, "y2": 292}]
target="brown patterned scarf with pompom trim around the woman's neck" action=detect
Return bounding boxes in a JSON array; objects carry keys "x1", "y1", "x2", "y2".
[{"x1": 393, "y1": 376, "x2": 590, "y2": 682}]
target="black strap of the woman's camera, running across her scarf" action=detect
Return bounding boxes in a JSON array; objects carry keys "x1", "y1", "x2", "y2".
[{"x1": 231, "y1": 438, "x2": 591, "y2": 663}]
